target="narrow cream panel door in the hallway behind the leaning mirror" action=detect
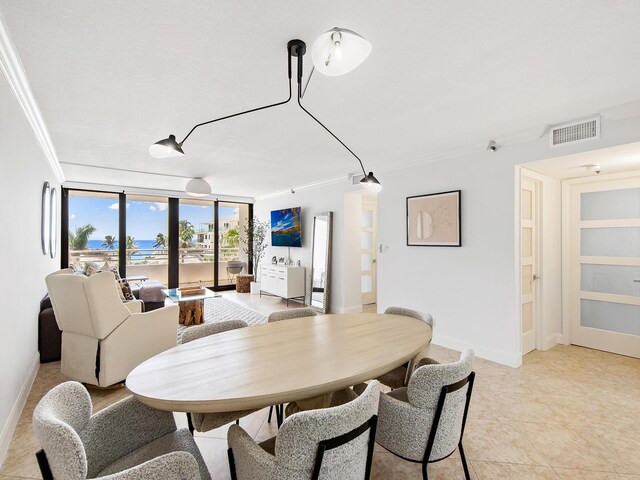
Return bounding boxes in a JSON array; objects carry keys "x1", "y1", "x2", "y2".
[{"x1": 360, "y1": 197, "x2": 378, "y2": 305}]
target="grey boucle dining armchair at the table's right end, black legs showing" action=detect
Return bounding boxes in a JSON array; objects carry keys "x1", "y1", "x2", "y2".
[{"x1": 377, "y1": 350, "x2": 474, "y2": 480}]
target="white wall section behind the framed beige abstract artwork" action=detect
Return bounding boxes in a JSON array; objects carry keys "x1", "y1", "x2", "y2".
[{"x1": 378, "y1": 150, "x2": 519, "y2": 364}]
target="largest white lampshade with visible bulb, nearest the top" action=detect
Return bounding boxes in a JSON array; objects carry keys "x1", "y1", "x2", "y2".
[{"x1": 311, "y1": 27, "x2": 371, "y2": 77}]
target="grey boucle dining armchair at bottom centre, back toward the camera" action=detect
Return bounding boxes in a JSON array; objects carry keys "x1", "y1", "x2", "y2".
[{"x1": 227, "y1": 380, "x2": 380, "y2": 480}]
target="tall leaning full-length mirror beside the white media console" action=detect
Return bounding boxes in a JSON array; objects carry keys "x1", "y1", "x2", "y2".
[{"x1": 310, "y1": 212, "x2": 333, "y2": 313}]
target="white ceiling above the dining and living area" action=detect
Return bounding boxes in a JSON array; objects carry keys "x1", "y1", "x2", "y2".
[{"x1": 0, "y1": 0, "x2": 640, "y2": 196}]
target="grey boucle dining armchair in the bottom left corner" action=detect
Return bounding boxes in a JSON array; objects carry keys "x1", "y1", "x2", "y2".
[{"x1": 33, "y1": 382, "x2": 211, "y2": 480}]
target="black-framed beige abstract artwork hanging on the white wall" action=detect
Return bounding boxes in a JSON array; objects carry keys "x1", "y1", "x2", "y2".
[{"x1": 406, "y1": 190, "x2": 462, "y2": 247}]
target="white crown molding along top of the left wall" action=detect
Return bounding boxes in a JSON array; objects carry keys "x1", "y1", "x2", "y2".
[{"x1": 0, "y1": 16, "x2": 64, "y2": 183}]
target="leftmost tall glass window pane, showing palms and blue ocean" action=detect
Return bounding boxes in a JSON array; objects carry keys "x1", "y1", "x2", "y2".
[{"x1": 68, "y1": 190, "x2": 119, "y2": 269}]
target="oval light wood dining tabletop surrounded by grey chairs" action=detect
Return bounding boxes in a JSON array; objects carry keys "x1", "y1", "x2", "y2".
[{"x1": 126, "y1": 313, "x2": 431, "y2": 413}]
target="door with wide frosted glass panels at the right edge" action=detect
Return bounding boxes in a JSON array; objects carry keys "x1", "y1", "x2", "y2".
[{"x1": 570, "y1": 177, "x2": 640, "y2": 358}]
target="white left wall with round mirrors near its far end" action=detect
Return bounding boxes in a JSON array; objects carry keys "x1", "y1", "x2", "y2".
[{"x1": 0, "y1": 75, "x2": 60, "y2": 463}]
